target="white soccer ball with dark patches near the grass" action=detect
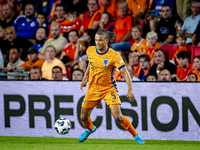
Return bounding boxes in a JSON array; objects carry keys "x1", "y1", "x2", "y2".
[{"x1": 54, "y1": 118, "x2": 71, "y2": 135}]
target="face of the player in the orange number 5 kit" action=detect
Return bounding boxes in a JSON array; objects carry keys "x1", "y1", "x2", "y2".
[{"x1": 95, "y1": 34, "x2": 108, "y2": 51}]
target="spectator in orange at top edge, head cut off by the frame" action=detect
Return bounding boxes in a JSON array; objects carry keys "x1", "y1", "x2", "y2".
[{"x1": 128, "y1": 0, "x2": 149, "y2": 19}]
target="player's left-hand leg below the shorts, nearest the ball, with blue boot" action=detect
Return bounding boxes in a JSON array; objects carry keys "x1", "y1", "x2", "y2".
[{"x1": 79, "y1": 101, "x2": 97, "y2": 142}]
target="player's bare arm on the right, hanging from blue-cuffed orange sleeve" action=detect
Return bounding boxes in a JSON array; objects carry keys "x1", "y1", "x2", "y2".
[{"x1": 120, "y1": 67, "x2": 135, "y2": 102}]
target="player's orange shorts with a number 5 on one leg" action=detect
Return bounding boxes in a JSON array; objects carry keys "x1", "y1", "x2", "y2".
[{"x1": 82, "y1": 90, "x2": 121, "y2": 108}]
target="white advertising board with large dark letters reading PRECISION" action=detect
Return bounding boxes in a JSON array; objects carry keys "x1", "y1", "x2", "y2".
[{"x1": 0, "y1": 81, "x2": 200, "y2": 141}]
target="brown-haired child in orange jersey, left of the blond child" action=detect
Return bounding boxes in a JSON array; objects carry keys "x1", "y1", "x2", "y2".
[{"x1": 131, "y1": 25, "x2": 147, "y2": 54}]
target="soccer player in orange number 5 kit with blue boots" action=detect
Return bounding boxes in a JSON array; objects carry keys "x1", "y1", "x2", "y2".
[{"x1": 79, "y1": 29, "x2": 145, "y2": 144}]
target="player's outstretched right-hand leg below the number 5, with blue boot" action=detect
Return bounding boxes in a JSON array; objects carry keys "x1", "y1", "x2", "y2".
[{"x1": 110, "y1": 105, "x2": 145, "y2": 144}]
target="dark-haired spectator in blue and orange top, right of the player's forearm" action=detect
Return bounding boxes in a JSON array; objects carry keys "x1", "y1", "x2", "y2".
[{"x1": 138, "y1": 54, "x2": 151, "y2": 81}]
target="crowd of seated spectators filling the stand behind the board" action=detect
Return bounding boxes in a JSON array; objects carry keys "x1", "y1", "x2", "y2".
[{"x1": 0, "y1": 0, "x2": 200, "y2": 82}]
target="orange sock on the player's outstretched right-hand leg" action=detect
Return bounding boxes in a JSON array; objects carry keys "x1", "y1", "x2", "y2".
[{"x1": 120, "y1": 116, "x2": 138, "y2": 136}]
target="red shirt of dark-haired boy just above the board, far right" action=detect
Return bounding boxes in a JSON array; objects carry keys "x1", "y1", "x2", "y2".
[{"x1": 176, "y1": 64, "x2": 195, "y2": 81}]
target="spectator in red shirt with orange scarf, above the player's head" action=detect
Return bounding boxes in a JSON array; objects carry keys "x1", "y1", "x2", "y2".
[{"x1": 79, "y1": 0, "x2": 101, "y2": 35}]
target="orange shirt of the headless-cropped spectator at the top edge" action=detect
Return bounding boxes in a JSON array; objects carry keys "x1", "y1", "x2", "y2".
[{"x1": 128, "y1": 0, "x2": 149, "y2": 15}]
